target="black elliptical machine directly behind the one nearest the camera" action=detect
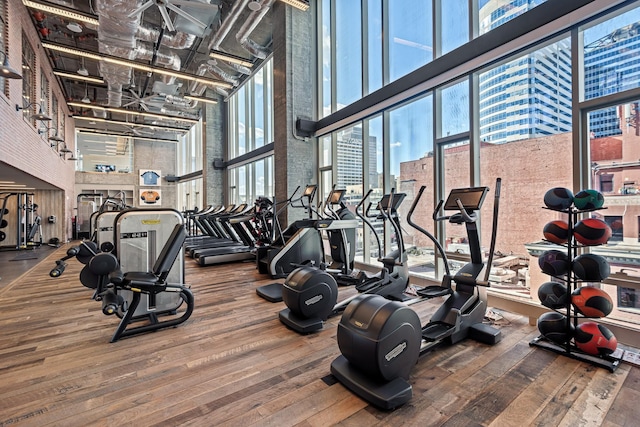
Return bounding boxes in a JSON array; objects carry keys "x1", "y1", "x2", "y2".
[{"x1": 278, "y1": 190, "x2": 409, "y2": 334}]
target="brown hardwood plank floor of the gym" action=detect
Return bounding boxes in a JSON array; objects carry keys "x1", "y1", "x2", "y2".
[{"x1": 0, "y1": 246, "x2": 640, "y2": 427}]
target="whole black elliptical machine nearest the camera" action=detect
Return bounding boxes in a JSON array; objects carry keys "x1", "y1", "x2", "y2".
[{"x1": 331, "y1": 178, "x2": 501, "y2": 409}]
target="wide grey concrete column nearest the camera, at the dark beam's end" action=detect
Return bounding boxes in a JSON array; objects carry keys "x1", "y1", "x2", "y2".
[{"x1": 272, "y1": 2, "x2": 318, "y2": 224}]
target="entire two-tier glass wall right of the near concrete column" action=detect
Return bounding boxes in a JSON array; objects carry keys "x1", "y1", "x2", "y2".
[{"x1": 318, "y1": 0, "x2": 640, "y2": 334}]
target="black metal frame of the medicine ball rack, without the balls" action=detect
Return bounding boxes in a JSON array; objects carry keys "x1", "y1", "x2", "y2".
[{"x1": 529, "y1": 206, "x2": 620, "y2": 372}]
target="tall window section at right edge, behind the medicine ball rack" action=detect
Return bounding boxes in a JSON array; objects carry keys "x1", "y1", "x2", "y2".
[{"x1": 580, "y1": 8, "x2": 640, "y2": 321}]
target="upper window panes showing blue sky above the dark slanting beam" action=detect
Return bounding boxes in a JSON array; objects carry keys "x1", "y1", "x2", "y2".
[{"x1": 318, "y1": 0, "x2": 545, "y2": 117}]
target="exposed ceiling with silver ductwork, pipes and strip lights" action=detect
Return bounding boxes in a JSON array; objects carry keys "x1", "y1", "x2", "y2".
[{"x1": 21, "y1": 0, "x2": 275, "y2": 135}]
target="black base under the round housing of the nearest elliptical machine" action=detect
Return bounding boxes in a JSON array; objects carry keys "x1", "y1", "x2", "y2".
[{"x1": 331, "y1": 356, "x2": 413, "y2": 410}]
